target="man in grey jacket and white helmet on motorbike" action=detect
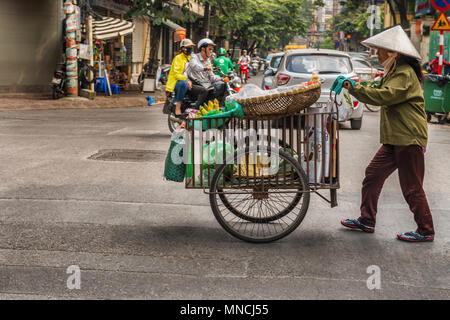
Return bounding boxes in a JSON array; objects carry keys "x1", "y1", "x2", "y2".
[{"x1": 186, "y1": 38, "x2": 226, "y2": 109}]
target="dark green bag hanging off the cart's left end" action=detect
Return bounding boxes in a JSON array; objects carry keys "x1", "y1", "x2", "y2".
[{"x1": 164, "y1": 130, "x2": 186, "y2": 182}]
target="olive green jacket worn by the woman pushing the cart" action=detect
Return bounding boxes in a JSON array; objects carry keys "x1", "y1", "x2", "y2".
[{"x1": 349, "y1": 61, "x2": 428, "y2": 147}]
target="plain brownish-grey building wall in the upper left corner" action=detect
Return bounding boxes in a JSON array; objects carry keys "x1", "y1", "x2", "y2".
[{"x1": 0, "y1": 0, "x2": 63, "y2": 93}]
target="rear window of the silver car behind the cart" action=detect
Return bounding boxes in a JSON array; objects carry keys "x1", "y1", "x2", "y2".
[{"x1": 287, "y1": 54, "x2": 352, "y2": 74}]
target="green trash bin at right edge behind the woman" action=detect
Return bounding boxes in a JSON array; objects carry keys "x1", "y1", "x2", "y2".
[{"x1": 423, "y1": 74, "x2": 450, "y2": 114}]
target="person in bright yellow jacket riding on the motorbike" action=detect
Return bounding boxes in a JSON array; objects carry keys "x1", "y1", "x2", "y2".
[{"x1": 166, "y1": 39, "x2": 194, "y2": 116}]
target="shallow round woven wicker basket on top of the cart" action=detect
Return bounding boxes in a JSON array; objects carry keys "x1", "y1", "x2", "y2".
[{"x1": 236, "y1": 82, "x2": 321, "y2": 117}]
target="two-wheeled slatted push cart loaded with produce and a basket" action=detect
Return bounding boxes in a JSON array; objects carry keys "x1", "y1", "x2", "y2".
[{"x1": 184, "y1": 84, "x2": 339, "y2": 242}]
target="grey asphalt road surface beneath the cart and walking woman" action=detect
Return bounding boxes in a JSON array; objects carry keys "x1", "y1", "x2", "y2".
[{"x1": 0, "y1": 78, "x2": 450, "y2": 300}]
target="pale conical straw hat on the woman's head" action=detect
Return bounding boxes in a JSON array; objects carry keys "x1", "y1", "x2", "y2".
[{"x1": 361, "y1": 26, "x2": 422, "y2": 60}]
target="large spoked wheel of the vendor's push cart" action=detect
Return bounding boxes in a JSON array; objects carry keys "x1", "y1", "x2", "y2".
[{"x1": 209, "y1": 148, "x2": 310, "y2": 243}]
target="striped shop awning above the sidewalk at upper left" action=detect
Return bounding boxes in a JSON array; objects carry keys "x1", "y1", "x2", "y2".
[{"x1": 92, "y1": 17, "x2": 134, "y2": 40}]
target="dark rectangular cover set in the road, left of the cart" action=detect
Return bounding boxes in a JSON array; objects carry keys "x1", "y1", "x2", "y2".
[{"x1": 88, "y1": 149, "x2": 166, "y2": 162}]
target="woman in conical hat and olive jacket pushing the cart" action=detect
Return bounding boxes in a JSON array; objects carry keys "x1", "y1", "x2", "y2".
[{"x1": 333, "y1": 26, "x2": 434, "y2": 242}]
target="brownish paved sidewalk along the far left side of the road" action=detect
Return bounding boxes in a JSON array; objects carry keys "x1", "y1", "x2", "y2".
[{"x1": 0, "y1": 90, "x2": 165, "y2": 111}]
